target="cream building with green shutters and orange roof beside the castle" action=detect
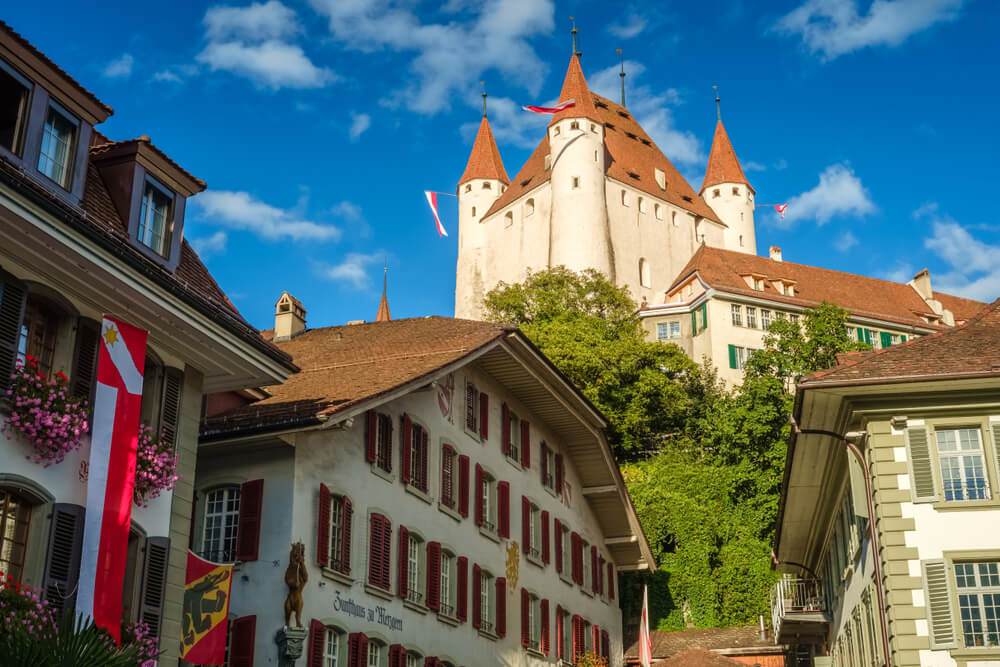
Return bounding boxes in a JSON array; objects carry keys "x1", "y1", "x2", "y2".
[{"x1": 639, "y1": 246, "x2": 985, "y2": 386}]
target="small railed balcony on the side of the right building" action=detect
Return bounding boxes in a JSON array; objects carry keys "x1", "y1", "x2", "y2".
[{"x1": 771, "y1": 576, "x2": 830, "y2": 644}]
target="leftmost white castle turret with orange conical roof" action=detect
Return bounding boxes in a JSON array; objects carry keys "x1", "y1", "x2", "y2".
[{"x1": 455, "y1": 103, "x2": 510, "y2": 319}]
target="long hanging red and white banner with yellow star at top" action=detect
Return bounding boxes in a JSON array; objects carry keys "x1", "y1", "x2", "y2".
[{"x1": 76, "y1": 316, "x2": 146, "y2": 642}]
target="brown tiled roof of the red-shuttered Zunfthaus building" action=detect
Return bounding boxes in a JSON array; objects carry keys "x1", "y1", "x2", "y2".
[{"x1": 202, "y1": 316, "x2": 514, "y2": 436}]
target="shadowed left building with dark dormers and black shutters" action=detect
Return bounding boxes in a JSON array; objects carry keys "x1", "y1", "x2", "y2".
[{"x1": 0, "y1": 23, "x2": 294, "y2": 665}]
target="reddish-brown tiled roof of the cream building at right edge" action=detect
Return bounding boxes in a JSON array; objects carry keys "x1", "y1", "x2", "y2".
[{"x1": 800, "y1": 299, "x2": 1000, "y2": 388}]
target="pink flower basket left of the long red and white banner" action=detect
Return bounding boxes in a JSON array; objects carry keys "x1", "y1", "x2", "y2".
[{"x1": 3, "y1": 355, "x2": 87, "y2": 468}]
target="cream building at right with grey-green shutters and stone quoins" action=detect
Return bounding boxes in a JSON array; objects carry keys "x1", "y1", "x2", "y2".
[{"x1": 772, "y1": 302, "x2": 1000, "y2": 667}]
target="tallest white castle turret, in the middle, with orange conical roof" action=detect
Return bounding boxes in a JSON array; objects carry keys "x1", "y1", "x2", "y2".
[{"x1": 547, "y1": 53, "x2": 615, "y2": 281}]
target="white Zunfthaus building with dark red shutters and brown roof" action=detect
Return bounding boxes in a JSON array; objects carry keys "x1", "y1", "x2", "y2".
[{"x1": 194, "y1": 308, "x2": 655, "y2": 667}]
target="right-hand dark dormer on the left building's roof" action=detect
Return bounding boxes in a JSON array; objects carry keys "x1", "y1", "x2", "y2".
[{"x1": 90, "y1": 136, "x2": 205, "y2": 271}]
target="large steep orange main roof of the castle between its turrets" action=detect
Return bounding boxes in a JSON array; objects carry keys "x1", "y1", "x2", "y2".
[{"x1": 486, "y1": 75, "x2": 722, "y2": 224}]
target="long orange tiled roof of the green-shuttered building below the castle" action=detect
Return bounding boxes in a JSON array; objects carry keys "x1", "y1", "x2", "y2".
[{"x1": 667, "y1": 245, "x2": 985, "y2": 329}]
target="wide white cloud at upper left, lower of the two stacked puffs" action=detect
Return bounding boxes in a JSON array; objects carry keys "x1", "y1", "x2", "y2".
[{"x1": 197, "y1": 40, "x2": 336, "y2": 90}]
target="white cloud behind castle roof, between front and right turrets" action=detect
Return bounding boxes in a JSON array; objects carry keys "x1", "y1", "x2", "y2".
[{"x1": 587, "y1": 60, "x2": 708, "y2": 166}]
